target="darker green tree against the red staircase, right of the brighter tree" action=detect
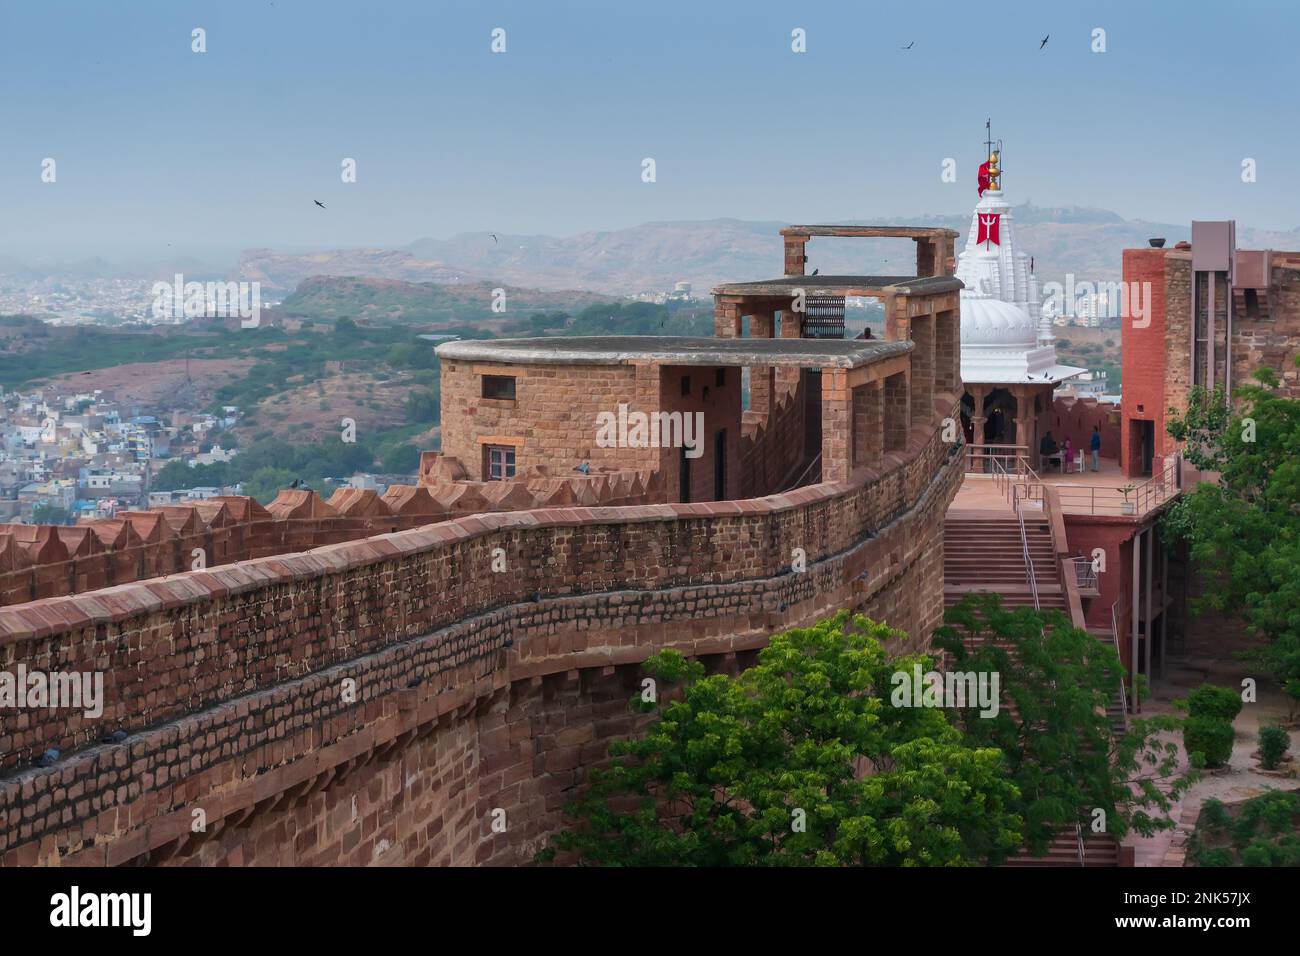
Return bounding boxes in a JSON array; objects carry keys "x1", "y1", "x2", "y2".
[{"x1": 933, "y1": 594, "x2": 1196, "y2": 855}]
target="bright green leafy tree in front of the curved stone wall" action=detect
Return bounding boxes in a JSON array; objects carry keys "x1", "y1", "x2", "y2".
[{"x1": 541, "y1": 613, "x2": 1022, "y2": 866}]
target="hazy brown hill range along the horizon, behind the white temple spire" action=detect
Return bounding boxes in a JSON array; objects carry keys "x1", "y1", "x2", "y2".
[{"x1": 228, "y1": 210, "x2": 1300, "y2": 295}]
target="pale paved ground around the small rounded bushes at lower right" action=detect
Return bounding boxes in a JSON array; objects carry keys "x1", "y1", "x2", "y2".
[{"x1": 1134, "y1": 658, "x2": 1300, "y2": 866}]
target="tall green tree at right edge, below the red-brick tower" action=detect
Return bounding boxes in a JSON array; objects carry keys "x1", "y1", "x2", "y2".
[{"x1": 1164, "y1": 369, "x2": 1300, "y2": 718}]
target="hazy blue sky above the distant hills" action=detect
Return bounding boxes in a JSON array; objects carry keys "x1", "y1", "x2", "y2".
[{"x1": 0, "y1": 0, "x2": 1300, "y2": 261}]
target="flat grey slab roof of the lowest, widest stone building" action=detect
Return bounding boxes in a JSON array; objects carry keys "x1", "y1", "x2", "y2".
[{"x1": 434, "y1": 336, "x2": 911, "y2": 368}]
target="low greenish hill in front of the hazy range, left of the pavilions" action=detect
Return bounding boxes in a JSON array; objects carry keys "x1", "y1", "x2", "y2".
[{"x1": 276, "y1": 276, "x2": 614, "y2": 325}]
